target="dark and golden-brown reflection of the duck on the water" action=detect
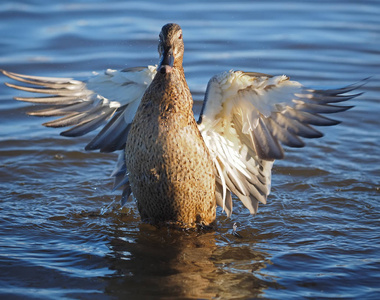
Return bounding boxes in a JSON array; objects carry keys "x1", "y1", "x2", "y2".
[{"x1": 101, "y1": 209, "x2": 279, "y2": 299}]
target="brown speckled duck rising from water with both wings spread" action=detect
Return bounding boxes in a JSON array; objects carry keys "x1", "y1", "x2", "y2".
[{"x1": 1, "y1": 23, "x2": 365, "y2": 228}]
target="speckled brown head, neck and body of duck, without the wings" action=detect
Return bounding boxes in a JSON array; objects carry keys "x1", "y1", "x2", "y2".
[{"x1": 125, "y1": 24, "x2": 216, "y2": 227}]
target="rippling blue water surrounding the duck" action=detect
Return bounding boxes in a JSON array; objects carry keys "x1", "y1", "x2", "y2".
[{"x1": 0, "y1": 0, "x2": 380, "y2": 299}]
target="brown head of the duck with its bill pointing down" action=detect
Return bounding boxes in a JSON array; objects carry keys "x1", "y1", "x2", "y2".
[{"x1": 157, "y1": 23, "x2": 185, "y2": 74}]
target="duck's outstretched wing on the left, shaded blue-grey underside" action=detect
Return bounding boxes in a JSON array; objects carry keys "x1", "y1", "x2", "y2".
[{"x1": 1, "y1": 66, "x2": 156, "y2": 152}]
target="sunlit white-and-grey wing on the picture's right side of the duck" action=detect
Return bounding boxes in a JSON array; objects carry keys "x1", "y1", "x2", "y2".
[{"x1": 198, "y1": 71, "x2": 364, "y2": 215}]
